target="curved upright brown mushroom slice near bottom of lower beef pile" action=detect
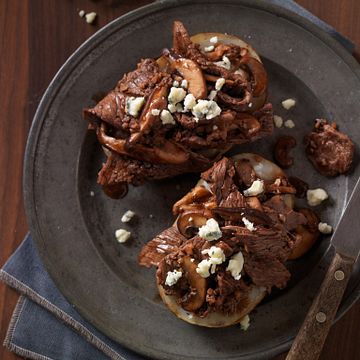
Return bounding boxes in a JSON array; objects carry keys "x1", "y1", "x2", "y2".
[{"x1": 180, "y1": 256, "x2": 207, "y2": 312}]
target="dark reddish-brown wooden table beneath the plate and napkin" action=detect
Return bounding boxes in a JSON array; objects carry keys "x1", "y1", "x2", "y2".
[{"x1": 0, "y1": 0, "x2": 360, "y2": 360}]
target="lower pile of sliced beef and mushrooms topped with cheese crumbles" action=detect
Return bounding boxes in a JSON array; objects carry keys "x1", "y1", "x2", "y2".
[{"x1": 139, "y1": 154, "x2": 319, "y2": 318}]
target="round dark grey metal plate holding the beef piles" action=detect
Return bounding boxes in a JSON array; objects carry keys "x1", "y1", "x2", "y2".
[{"x1": 24, "y1": 0, "x2": 360, "y2": 359}]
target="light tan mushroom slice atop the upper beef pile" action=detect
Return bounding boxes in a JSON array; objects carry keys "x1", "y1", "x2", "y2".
[{"x1": 169, "y1": 58, "x2": 207, "y2": 99}]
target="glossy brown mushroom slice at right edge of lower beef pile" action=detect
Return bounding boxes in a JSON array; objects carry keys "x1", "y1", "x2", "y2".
[{"x1": 289, "y1": 209, "x2": 320, "y2": 260}]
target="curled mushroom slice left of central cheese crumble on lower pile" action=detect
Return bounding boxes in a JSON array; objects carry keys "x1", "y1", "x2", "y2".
[{"x1": 176, "y1": 210, "x2": 211, "y2": 239}]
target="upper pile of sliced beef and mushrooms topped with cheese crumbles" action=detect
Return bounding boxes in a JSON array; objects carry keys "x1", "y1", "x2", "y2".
[{"x1": 84, "y1": 22, "x2": 273, "y2": 194}]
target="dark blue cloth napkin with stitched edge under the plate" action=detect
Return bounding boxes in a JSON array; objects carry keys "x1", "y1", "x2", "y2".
[{"x1": 0, "y1": 0, "x2": 354, "y2": 360}]
